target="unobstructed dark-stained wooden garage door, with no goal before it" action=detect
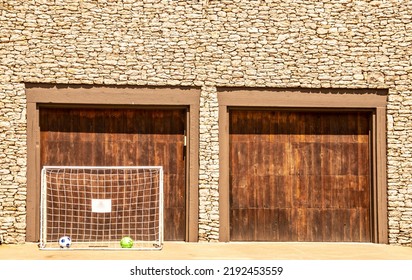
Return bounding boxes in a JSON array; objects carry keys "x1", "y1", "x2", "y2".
[{"x1": 229, "y1": 110, "x2": 371, "y2": 242}]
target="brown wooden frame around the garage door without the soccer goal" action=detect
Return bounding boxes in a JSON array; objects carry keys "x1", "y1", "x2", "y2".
[{"x1": 218, "y1": 88, "x2": 389, "y2": 244}]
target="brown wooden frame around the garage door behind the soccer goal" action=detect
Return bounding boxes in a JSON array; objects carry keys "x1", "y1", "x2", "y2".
[{"x1": 26, "y1": 84, "x2": 200, "y2": 242}]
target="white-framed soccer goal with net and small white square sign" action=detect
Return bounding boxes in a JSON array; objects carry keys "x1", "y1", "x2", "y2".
[{"x1": 39, "y1": 166, "x2": 163, "y2": 250}]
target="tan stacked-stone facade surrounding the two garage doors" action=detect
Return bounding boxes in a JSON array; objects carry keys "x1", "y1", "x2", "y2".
[{"x1": 0, "y1": 0, "x2": 412, "y2": 245}]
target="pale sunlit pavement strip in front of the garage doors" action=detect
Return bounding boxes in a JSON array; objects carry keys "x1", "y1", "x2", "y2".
[{"x1": 0, "y1": 242, "x2": 412, "y2": 260}]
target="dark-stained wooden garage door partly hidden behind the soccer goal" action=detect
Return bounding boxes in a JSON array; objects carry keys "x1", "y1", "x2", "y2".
[{"x1": 40, "y1": 108, "x2": 186, "y2": 240}]
